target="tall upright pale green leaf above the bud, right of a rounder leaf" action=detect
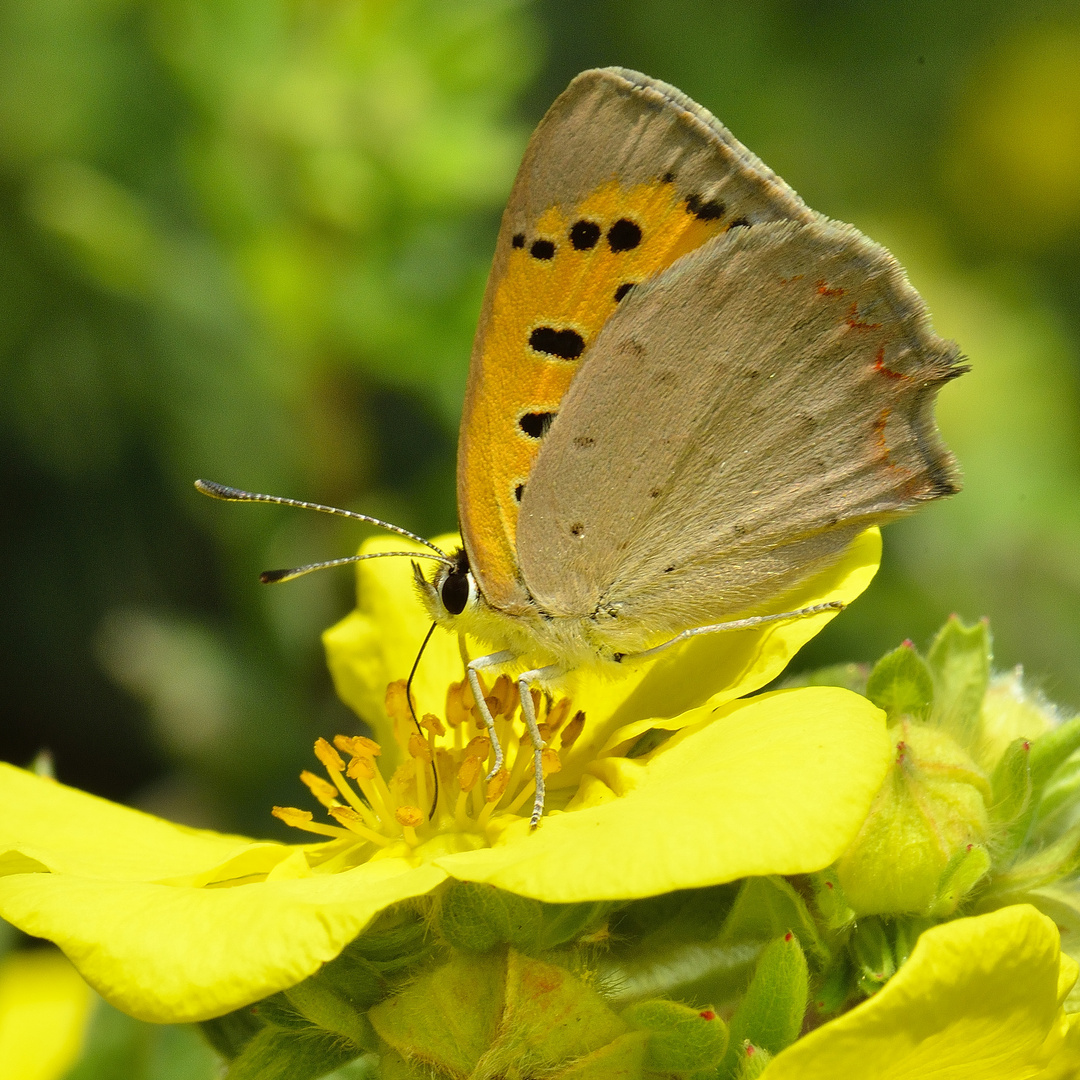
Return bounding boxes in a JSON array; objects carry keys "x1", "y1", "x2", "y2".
[{"x1": 927, "y1": 616, "x2": 991, "y2": 748}]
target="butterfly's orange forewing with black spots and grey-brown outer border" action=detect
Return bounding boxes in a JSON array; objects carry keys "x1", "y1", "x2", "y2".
[{"x1": 458, "y1": 68, "x2": 816, "y2": 611}]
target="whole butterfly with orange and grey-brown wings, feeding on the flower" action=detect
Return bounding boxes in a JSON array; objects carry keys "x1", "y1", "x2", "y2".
[{"x1": 198, "y1": 68, "x2": 967, "y2": 826}]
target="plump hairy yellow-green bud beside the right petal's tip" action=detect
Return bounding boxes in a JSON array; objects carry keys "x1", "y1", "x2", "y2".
[{"x1": 836, "y1": 719, "x2": 990, "y2": 915}]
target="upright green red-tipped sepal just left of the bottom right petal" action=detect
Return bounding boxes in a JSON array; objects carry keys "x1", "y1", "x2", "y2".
[{"x1": 720, "y1": 932, "x2": 810, "y2": 1077}]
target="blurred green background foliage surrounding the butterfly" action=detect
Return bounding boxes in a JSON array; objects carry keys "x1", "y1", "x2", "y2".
[{"x1": 0, "y1": 0, "x2": 1080, "y2": 835}]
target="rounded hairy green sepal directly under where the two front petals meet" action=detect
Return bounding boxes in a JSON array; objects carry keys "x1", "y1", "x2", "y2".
[{"x1": 435, "y1": 881, "x2": 543, "y2": 953}]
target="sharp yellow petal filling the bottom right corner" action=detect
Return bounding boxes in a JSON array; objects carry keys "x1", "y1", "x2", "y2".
[{"x1": 764, "y1": 904, "x2": 1080, "y2": 1080}]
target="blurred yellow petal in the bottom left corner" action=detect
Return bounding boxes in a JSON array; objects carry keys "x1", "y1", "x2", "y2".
[{"x1": 0, "y1": 948, "x2": 93, "y2": 1080}]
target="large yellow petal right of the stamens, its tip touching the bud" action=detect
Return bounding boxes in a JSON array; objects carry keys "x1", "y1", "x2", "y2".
[{"x1": 436, "y1": 687, "x2": 890, "y2": 902}]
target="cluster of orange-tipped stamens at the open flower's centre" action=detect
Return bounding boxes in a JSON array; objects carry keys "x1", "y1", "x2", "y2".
[{"x1": 273, "y1": 675, "x2": 585, "y2": 853}]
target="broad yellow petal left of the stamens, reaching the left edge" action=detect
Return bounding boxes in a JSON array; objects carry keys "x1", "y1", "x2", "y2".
[{"x1": 0, "y1": 767, "x2": 445, "y2": 1023}]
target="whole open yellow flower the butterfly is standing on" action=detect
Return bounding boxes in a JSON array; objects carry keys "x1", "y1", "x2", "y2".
[{"x1": 0, "y1": 531, "x2": 889, "y2": 1022}]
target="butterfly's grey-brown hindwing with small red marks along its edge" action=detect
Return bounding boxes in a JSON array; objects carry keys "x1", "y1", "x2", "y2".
[{"x1": 517, "y1": 219, "x2": 961, "y2": 648}]
